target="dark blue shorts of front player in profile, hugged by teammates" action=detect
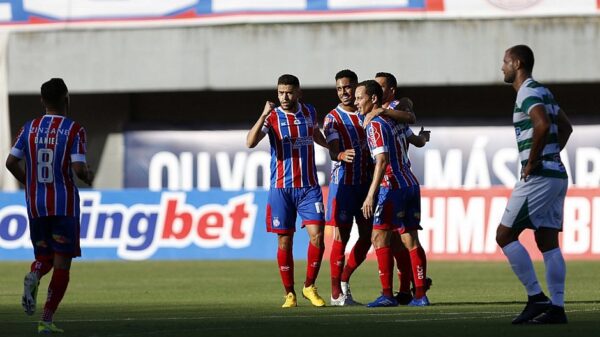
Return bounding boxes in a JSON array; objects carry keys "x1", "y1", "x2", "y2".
[{"x1": 373, "y1": 185, "x2": 423, "y2": 234}]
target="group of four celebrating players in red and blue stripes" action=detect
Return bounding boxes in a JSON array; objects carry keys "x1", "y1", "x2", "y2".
[{"x1": 247, "y1": 69, "x2": 431, "y2": 308}]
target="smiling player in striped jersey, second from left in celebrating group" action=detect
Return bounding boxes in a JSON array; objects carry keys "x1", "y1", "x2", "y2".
[{"x1": 323, "y1": 69, "x2": 373, "y2": 306}]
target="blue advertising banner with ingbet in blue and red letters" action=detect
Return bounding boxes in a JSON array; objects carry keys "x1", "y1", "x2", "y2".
[{"x1": 0, "y1": 189, "x2": 308, "y2": 260}]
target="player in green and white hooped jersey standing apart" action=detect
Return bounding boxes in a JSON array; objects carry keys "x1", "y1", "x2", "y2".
[{"x1": 496, "y1": 45, "x2": 573, "y2": 324}]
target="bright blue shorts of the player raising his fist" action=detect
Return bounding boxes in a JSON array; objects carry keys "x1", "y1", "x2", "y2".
[{"x1": 267, "y1": 186, "x2": 325, "y2": 233}]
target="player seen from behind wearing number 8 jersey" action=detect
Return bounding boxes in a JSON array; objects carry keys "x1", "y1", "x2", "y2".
[{"x1": 6, "y1": 78, "x2": 93, "y2": 333}]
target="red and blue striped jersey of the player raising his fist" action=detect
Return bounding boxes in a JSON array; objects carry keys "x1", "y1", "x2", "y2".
[{"x1": 262, "y1": 103, "x2": 320, "y2": 188}]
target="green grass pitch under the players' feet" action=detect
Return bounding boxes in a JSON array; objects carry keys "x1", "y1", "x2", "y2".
[{"x1": 0, "y1": 261, "x2": 600, "y2": 337}]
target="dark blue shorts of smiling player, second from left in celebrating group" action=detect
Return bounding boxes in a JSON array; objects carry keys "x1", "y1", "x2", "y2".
[{"x1": 325, "y1": 183, "x2": 373, "y2": 227}]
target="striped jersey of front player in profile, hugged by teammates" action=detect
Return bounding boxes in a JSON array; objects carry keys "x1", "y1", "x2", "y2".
[{"x1": 367, "y1": 116, "x2": 419, "y2": 189}]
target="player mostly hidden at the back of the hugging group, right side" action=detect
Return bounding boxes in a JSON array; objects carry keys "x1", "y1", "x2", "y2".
[{"x1": 375, "y1": 72, "x2": 431, "y2": 306}]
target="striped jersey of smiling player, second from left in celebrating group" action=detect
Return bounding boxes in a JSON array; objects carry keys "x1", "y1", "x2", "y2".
[{"x1": 323, "y1": 106, "x2": 373, "y2": 185}]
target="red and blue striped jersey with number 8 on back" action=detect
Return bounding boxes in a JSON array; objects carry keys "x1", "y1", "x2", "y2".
[{"x1": 10, "y1": 115, "x2": 86, "y2": 218}]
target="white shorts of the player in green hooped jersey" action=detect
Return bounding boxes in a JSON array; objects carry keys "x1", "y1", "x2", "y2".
[{"x1": 501, "y1": 176, "x2": 568, "y2": 230}]
